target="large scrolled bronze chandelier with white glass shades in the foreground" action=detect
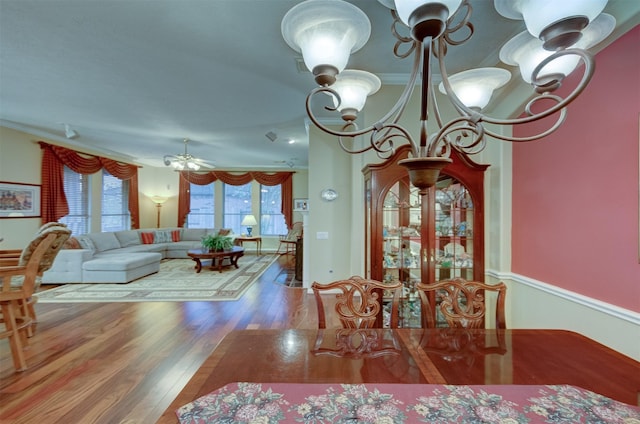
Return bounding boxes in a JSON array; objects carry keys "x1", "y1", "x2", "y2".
[{"x1": 281, "y1": 0, "x2": 615, "y2": 194}]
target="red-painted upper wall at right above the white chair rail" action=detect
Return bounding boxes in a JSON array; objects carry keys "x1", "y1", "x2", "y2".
[{"x1": 511, "y1": 26, "x2": 640, "y2": 312}]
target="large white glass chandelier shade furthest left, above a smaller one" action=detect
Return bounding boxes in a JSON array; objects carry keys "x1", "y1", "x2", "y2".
[{"x1": 281, "y1": 0, "x2": 371, "y2": 72}]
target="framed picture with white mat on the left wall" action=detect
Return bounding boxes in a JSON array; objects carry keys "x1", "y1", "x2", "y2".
[{"x1": 0, "y1": 181, "x2": 42, "y2": 219}]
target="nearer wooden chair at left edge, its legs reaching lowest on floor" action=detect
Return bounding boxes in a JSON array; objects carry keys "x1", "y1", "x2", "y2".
[{"x1": 0, "y1": 233, "x2": 58, "y2": 371}]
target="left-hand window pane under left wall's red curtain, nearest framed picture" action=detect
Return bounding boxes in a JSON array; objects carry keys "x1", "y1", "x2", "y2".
[{"x1": 60, "y1": 166, "x2": 91, "y2": 235}]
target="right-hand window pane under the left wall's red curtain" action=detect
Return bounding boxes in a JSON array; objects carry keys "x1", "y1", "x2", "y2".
[{"x1": 100, "y1": 169, "x2": 131, "y2": 231}]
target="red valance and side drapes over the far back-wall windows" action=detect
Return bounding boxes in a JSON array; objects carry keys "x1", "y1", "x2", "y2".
[{"x1": 178, "y1": 171, "x2": 293, "y2": 228}]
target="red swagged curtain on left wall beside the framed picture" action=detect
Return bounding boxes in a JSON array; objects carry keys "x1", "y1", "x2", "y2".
[{"x1": 38, "y1": 141, "x2": 140, "y2": 228}]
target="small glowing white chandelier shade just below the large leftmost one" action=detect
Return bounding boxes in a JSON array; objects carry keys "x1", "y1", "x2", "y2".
[{"x1": 331, "y1": 69, "x2": 381, "y2": 112}]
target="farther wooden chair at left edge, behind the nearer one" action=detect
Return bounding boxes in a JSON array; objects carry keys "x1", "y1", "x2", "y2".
[{"x1": 0, "y1": 223, "x2": 71, "y2": 328}]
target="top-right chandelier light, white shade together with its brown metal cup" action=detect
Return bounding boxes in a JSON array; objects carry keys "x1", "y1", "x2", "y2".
[{"x1": 494, "y1": 0, "x2": 608, "y2": 50}]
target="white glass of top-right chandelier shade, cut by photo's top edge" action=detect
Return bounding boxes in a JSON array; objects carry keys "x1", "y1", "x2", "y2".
[{"x1": 494, "y1": 0, "x2": 608, "y2": 38}]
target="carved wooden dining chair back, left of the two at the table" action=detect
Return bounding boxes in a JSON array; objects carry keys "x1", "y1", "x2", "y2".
[{"x1": 311, "y1": 276, "x2": 402, "y2": 328}]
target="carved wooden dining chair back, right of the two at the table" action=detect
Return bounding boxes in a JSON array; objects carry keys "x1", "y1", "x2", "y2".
[{"x1": 416, "y1": 278, "x2": 507, "y2": 329}]
